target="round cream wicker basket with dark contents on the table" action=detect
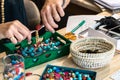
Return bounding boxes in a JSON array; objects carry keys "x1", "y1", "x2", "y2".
[{"x1": 70, "y1": 37, "x2": 115, "y2": 68}]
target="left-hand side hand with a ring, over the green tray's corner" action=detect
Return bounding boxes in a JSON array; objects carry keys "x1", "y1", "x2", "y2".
[{"x1": 0, "y1": 20, "x2": 31, "y2": 44}]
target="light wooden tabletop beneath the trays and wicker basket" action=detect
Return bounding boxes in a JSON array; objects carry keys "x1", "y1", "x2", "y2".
[{"x1": 0, "y1": 12, "x2": 120, "y2": 80}]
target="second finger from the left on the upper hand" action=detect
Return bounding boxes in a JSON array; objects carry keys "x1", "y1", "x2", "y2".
[{"x1": 46, "y1": 8, "x2": 58, "y2": 28}]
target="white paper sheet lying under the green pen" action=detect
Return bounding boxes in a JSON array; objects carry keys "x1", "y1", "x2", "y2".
[{"x1": 66, "y1": 15, "x2": 104, "y2": 35}]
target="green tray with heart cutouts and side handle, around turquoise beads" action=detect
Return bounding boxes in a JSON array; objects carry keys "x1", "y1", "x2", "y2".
[{"x1": 3, "y1": 31, "x2": 71, "y2": 69}]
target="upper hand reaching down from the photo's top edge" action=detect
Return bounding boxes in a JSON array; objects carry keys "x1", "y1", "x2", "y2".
[{"x1": 41, "y1": 0, "x2": 70, "y2": 32}]
